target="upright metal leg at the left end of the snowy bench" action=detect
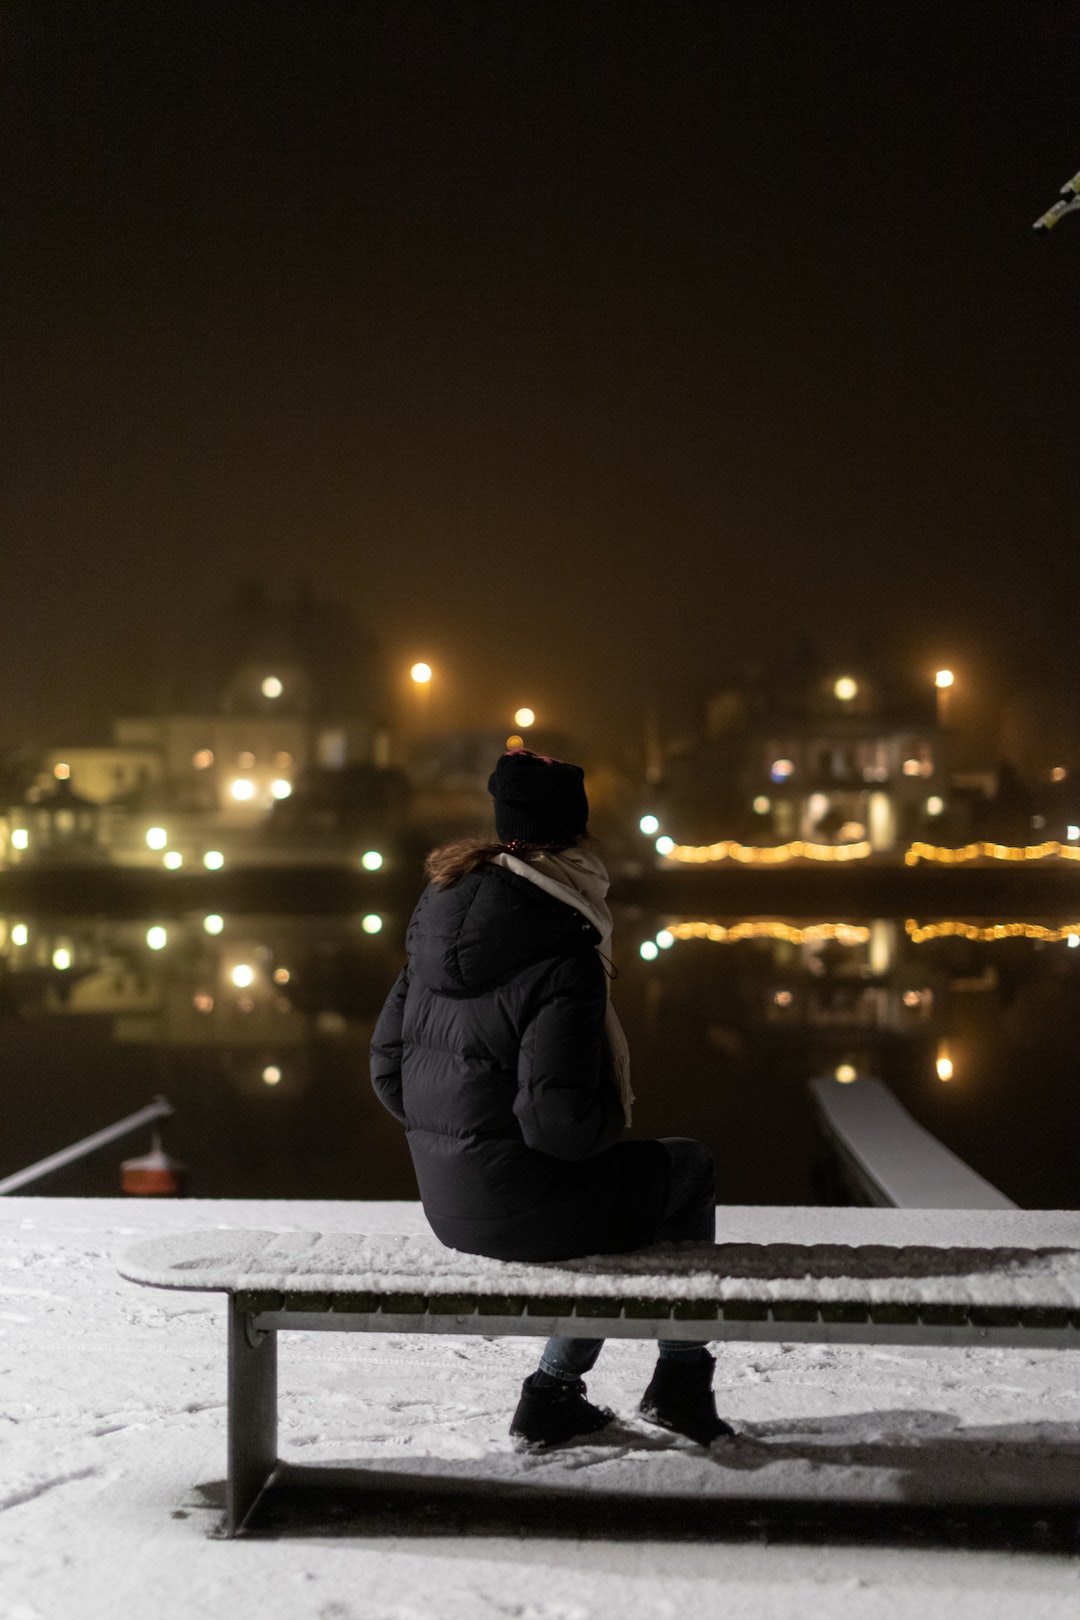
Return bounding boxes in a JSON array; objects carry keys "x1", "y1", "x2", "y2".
[{"x1": 225, "y1": 1296, "x2": 277, "y2": 1536}]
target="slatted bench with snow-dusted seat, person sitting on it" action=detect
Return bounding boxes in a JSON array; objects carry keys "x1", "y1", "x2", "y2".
[{"x1": 120, "y1": 1207, "x2": 1080, "y2": 1536}]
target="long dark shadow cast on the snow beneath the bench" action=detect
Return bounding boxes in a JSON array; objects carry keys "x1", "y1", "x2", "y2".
[{"x1": 202, "y1": 1411, "x2": 1080, "y2": 1554}]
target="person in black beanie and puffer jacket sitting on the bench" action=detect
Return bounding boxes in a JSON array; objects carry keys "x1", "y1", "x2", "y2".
[{"x1": 371, "y1": 748, "x2": 730, "y2": 1448}]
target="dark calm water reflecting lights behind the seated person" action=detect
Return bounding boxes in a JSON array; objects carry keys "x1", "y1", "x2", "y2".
[{"x1": 0, "y1": 912, "x2": 1080, "y2": 1209}]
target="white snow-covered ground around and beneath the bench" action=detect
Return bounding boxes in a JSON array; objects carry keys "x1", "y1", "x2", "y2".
[{"x1": 0, "y1": 1199, "x2": 1080, "y2": 1620}]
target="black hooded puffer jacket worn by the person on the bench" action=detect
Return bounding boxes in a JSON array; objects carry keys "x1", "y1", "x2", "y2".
[{"x1": 371, "y1": 865, "x2": 667, "y2": 1260}]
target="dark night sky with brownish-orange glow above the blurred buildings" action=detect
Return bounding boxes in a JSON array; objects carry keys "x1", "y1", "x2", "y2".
[{"x1": 0, "y1": 0, "x2": 1080, "y2": 744}]
